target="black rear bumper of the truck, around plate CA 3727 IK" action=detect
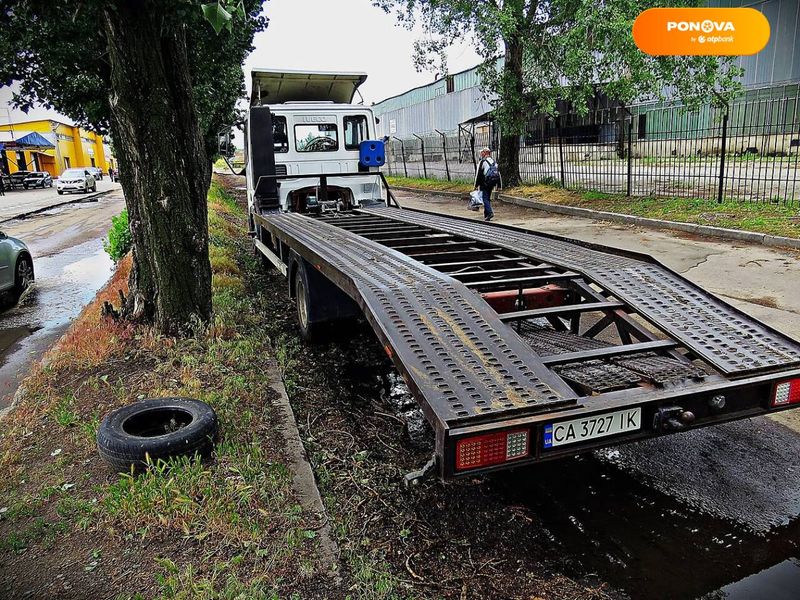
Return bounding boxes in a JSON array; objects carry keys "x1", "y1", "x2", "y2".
[{"x1": 440, "y1": 369, "x2": 800, "y2": 479}]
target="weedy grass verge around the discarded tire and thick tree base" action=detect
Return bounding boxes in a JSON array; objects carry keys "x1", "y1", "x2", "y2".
[{"x1": 0, "y1": 182, "x2": 317, "y2": 599}]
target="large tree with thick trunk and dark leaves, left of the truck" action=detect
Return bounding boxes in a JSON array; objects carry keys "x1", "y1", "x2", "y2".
[{"x1": 0, "y1": 0, "x2": 267, "y2": 333}]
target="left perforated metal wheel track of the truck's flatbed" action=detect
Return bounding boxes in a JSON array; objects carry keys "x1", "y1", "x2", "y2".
[{"x1": 259, "y1": 213, "x2": 577, "y2": 423}]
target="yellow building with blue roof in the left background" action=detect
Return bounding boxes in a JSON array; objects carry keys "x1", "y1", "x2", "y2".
[{"x1": 0, "y1": 119, "x2": 117, "y2": 177}]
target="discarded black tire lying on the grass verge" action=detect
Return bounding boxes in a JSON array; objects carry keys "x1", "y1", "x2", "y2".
[{"x1": 97, "y1": 398, "x2": 217, "y2": 471}]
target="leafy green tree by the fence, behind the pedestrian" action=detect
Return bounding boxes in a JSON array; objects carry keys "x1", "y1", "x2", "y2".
[{"x1": 373, "y1": 0, "x2": 739, "y2": 185}]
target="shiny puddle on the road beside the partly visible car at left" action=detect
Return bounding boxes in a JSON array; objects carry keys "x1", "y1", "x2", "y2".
[{"x1": 0, "y1": 239, "x2": 113, "y2": 409}]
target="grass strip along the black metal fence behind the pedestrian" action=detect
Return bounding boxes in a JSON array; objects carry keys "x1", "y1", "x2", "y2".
[{"x1": 387, "y1": 177, "x2": 800, "y2": 238}]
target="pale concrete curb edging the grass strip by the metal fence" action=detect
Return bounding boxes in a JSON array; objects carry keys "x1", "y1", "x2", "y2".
[{"x1": 500, "y1": 194, "x2": 800, "y2": 249}]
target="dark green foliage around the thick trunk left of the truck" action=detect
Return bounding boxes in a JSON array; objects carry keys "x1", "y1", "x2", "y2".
[{"x1": 0, "y1": 0, "x2": 268, "y2": 156}]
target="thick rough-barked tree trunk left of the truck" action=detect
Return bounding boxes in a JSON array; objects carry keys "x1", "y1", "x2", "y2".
[{"x1": 104, "y1": 0, "x2": 211, "y2": 334}]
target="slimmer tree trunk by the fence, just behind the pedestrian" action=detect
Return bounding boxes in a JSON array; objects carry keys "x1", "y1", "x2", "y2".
[{"x1": 499, "y1": 39, "x2": 528, "y2": 187}]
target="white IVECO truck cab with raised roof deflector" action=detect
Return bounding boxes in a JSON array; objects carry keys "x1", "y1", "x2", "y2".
[{"x1": 245, "y1": 70, "x2": 383, "y2": 212}]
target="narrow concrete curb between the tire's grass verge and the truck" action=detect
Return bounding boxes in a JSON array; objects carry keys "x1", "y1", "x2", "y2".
[{"x1": 267, "y1": 360, "x2": 341, "y2": 584}]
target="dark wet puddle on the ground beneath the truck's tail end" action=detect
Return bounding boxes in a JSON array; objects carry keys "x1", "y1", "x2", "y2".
[{"x1": 340, "y1": 338, "x2": 800, "y2": 600}]
